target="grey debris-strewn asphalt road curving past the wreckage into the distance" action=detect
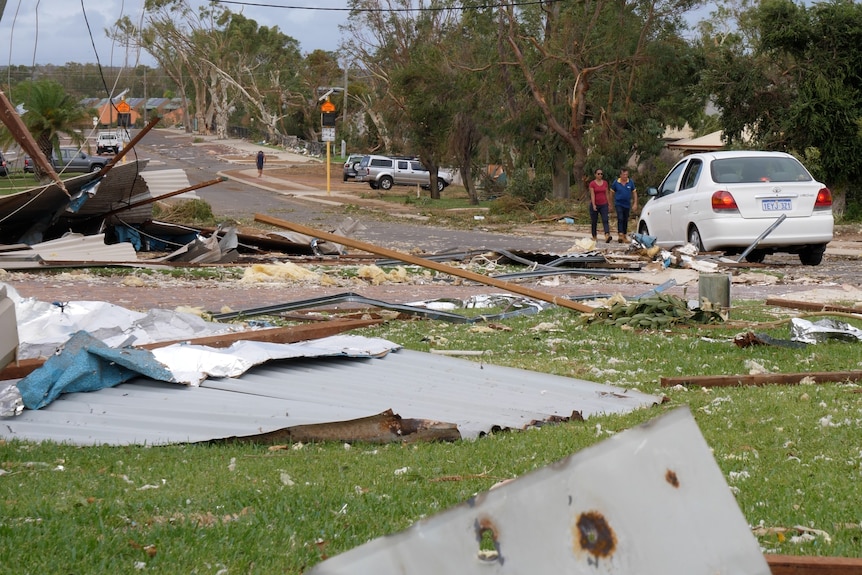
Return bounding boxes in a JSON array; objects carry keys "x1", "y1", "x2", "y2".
[{"x1": 136, "y1": 130, "x2": 862, "y2": 291}]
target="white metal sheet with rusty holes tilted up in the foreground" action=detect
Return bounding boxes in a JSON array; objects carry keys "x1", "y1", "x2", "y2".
[{"x1": 307, "y1": 408, "x2": 770, "y2": 575}]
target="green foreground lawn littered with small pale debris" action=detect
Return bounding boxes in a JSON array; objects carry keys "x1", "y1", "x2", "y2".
[{"x1": 0, "y1": 296, "x2": 862, "y2": 574}]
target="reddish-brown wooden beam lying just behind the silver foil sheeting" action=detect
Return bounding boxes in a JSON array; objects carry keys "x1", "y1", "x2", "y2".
[{"x1": 0, "y1": 319, "x2": 384, "y2": 381}]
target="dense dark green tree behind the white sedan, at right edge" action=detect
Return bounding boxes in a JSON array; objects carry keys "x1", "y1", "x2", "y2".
[{"x1": 701, "y1": 0, "x2": 862, "y2": 215}]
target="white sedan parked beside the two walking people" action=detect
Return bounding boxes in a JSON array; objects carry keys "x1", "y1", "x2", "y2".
[{"x1": 638, "y1": 151, "x2": 834, "y2": 266}]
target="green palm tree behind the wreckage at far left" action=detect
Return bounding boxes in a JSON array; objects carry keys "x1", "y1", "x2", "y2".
[{"x1": 0, "y1": 80, "x2": 89, "y2": 179}]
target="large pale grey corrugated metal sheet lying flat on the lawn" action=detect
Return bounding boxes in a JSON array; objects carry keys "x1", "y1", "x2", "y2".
[{"x1": 0, "y1": 350, "x2": 660, "y2": 445}]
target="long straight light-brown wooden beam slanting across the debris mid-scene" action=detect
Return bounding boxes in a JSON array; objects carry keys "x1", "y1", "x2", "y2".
[{"x1": 254, "y1": 214, "x2": 593, "y2": 313}]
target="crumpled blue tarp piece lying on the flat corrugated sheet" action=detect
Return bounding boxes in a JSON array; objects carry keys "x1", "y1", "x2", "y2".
[{"x1": 18, "y1": 331, "x2": 174, "y2": 409}]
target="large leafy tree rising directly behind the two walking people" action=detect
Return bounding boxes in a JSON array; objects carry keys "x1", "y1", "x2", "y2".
[{"x1": 500, "y1": 0, "x2": 702, "y2": 197}]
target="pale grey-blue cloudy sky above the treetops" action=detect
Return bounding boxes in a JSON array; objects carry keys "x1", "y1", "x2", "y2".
[{"x1": 0, "y1": 0, "x2": 347, "y2": 66}]
